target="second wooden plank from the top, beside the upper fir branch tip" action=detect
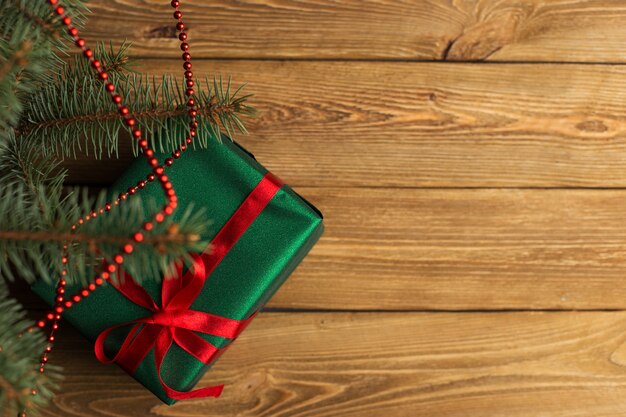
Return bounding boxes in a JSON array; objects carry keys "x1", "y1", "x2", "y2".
[{"x1": 62, "y1": 60, "x2": 626, "y2": 187}]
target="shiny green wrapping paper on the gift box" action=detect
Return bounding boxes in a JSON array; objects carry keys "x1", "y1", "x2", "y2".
[{"x1": 33, "y1": 139, "x2": 323, "y2": 404}]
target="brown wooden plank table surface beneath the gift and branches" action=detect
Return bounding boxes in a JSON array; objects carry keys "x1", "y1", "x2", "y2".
[{"x1": 26, "y1": 0, "x2": 626, "y2": 417}]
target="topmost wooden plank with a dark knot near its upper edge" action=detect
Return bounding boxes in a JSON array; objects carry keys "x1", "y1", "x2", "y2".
[{"x1": 80, "y1": 0, "x2": 626, "y2": 62}]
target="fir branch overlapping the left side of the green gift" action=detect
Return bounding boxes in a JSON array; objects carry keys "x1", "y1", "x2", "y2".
[{"x1": 0, "y1": 184, "x2": 209, "y2": 284}]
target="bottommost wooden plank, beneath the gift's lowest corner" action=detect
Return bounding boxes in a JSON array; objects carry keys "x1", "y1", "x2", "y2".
[{"x1": 36, "y1": 312, "x2": 626, "y2": 417}]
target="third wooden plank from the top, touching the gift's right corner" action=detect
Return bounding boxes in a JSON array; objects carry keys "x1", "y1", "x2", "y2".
[{"x1": 12, "y1": 187, "x2": 626, "y2": 310}]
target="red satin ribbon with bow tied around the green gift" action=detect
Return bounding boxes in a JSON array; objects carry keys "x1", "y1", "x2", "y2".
[{"x1": 95, "y1": 173, "x2": 282, "y2": 400}]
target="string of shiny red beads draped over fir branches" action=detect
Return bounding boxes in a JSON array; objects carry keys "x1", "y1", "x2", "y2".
[{"x1": 19, "y1": 0, "x2": 198, "y2": 417}]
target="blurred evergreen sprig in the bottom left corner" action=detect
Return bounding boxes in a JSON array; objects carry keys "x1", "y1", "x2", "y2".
[{"x1": 0, "y1": 281, "x2": 60, "y2": 417}]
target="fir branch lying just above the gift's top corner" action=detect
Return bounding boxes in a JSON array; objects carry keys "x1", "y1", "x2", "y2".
[{"x1": 16, "y1": 63, "x2": 255, "y2": 157}]
